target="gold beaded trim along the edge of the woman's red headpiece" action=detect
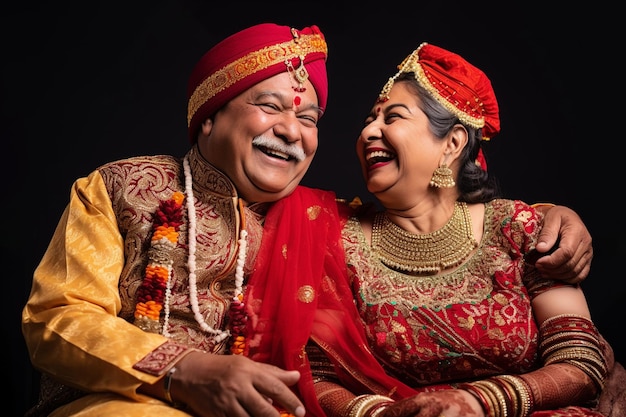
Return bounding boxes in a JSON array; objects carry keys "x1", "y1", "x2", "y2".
[{"x1": 378, "y1": 42, "x2": 485, "y2": 129}]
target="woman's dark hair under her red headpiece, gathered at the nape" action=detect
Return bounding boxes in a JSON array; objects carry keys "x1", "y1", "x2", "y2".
[{"x1": 395, "y1": 73, "x2": 500, "y2": 203}]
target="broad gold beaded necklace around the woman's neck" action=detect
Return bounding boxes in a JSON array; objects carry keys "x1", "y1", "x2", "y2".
[{"x1": 372, "y1": 202, "x2": 478, "y2": 275}]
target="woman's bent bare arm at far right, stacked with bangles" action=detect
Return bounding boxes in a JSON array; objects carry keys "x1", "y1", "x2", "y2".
[{"x1": 459, "y1": 286, "x2": 607, "y2": 415}]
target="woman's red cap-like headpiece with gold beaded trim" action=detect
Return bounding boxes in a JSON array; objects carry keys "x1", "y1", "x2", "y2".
[{"x1": 379, "y1": 43, "x2": 500, "y2": 140}]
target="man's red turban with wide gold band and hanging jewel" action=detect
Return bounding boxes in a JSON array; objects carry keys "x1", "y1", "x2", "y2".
[{"x1": 187, "y1": 23, "x2": 328, "y2": 143}]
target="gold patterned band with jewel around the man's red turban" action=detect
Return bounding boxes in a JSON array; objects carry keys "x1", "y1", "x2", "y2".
[{"x1": 187, "y1": 30, "x2": 328, "y2": 125}]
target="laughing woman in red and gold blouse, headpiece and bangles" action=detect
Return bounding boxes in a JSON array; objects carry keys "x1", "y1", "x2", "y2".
[{"x1": 309, "y1": 43, "x2": 611, "y2": 417}]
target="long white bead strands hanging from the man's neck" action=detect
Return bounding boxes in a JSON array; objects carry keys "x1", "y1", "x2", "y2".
[{"x1": 163, "y1": 156, "x2": 248, "y2": 343}]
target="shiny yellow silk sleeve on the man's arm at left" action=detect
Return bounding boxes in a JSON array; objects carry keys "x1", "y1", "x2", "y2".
[{"x1": 22, "y1": 171, "x2": 167, "y2": 398}]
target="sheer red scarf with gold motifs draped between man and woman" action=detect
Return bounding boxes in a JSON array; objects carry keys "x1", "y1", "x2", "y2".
[{"x1": 244, "y1": 186, "x2": 415, "y2": 417}]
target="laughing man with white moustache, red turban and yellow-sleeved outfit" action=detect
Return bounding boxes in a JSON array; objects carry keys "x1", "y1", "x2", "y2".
[{"x1": 23, "y1": 23, "x2": 592, "y2": 417}]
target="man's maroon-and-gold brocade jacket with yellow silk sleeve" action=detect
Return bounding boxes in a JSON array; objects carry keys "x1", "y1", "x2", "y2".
[{"x1": 22, "y1": 147, "x2": 267, "y2": 412}]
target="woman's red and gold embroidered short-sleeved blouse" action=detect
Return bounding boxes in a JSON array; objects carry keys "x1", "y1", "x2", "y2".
[{"x1": 343, "y1": 200, "x2": 553, "y2": 387}]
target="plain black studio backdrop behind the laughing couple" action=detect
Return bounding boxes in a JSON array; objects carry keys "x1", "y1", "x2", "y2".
[{"x1": 0, "y1": 0, "x2": 626, "y2": 415}]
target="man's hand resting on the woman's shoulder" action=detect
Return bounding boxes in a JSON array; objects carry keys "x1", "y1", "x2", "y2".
[{"x1": 535, "y1": 206, "x2": 593, "y2": 284}]
